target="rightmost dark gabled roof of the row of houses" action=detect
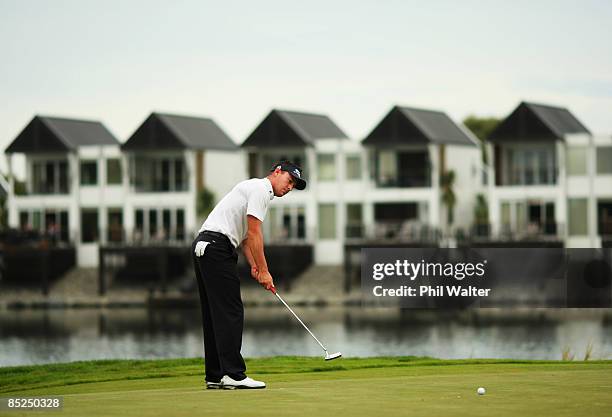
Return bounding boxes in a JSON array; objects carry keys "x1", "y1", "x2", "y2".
[{"x1": 488, "y1": 102, "x2": 590, "y2": 142}]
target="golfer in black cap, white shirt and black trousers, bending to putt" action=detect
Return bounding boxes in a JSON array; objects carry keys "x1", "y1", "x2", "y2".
[{"x1": 191, "y1": 161, "x2": 306, "y2": 389}]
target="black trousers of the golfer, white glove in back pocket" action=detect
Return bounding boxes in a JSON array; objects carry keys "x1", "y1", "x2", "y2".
[{"x1": 191, "y1": 232, "x2": 246, "y2": 382}]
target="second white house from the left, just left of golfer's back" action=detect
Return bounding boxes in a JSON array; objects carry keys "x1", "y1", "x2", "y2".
[{"x1": 121, "y1": 113, "x2": 246, "y2": 244}]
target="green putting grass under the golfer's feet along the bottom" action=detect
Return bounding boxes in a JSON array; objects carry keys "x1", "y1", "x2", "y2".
[{"x1": 0, "y1": 357, "x2": 612, "y2": 417}]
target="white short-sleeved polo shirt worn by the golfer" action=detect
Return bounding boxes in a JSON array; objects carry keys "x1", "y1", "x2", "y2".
[{"x1": 198, "y1": 178, "x2": 274, "y2": 247}]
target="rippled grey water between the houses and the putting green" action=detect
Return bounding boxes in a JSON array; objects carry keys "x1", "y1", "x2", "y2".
[{"x1": 0, "y1": 307, "x2": 612, "y2": 366}]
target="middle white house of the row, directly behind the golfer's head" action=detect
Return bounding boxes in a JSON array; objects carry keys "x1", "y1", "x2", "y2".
[{"x1": 241, "y1": 109, "x2": 354, "y2": 264}]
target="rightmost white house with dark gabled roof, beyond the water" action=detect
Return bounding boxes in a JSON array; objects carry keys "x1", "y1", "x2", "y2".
[{"x1": 488, "y1": 102, "x2": 612, "y2": 247}]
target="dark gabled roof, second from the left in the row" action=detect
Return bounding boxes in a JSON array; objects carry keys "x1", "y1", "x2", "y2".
[{"x1": 122, "y1": 113, "x2": 238, "y2": 151}]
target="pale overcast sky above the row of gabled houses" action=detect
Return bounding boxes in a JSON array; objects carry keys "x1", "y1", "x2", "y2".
[{"x1": 0, "y1": 0, "x2": 612, "y2": 177}]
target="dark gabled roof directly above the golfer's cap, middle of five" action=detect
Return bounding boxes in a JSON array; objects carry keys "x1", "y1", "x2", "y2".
[{"x1": 242, "y1": 109, "x2": 347, "y2": 147}]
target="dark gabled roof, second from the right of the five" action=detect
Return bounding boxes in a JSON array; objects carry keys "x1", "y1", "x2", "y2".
[{"x1": 362, "y1": 106, "x2": 476, "y2": 146}]
